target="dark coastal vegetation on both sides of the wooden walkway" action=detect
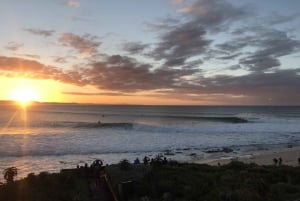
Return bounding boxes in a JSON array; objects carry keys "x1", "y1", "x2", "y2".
[{"x1": 0, "y1": 160, "x2": 300, "y2": 201}]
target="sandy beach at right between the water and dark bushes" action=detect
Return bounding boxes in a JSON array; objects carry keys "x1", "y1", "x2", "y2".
[{"x1": 194, "y1": 146, "x2": 300, "y2": 166}]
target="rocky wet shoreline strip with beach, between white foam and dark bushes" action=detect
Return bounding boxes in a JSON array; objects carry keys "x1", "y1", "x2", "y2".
[{"x1": 0, "y1": 143, "x2": 300, "y2": 182}]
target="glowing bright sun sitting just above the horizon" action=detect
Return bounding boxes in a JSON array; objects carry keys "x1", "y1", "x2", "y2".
[{"x1": 11, "y1": 87, "x2": 39, "y2": 106}]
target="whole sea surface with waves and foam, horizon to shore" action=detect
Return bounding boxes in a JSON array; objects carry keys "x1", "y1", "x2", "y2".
[{"x1": 0, "y1": 103, "x2": 300, "y2": 181}]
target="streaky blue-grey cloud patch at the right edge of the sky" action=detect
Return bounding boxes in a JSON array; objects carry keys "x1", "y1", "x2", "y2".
[{"x1": 216, "y1": 26, "x2": 300, "y2": 71}]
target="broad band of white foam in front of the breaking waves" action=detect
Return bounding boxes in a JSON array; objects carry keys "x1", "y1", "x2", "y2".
[{"x1": 0, "y1": 119, "x2": 300, "y2": 157}]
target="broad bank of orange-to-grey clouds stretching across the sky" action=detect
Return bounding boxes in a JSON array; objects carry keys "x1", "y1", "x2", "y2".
[{"x1": 0, "y1": 0, "x2": 300, "y2": 104}]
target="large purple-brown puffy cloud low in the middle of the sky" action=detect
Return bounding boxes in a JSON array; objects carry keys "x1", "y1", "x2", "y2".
[{"x1": 85, "y1": 55, "x2": 195, "y2": 92}]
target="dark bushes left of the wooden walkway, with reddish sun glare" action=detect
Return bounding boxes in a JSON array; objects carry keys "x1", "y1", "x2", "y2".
[{"x1": 0, "y1": 172, "x2": 89, "y2": 201}]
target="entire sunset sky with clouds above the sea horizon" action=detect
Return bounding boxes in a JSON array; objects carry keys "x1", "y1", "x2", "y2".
[{"x1": 0, "y1": 0, "x2": 300, "y2": 105}]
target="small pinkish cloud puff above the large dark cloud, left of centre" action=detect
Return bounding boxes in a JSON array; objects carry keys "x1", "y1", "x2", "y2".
[{"x1": 58, "y1": 33, "x2": 101, "y2": 57}]
